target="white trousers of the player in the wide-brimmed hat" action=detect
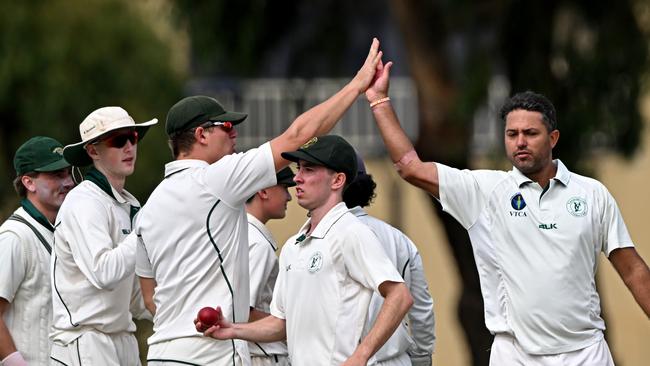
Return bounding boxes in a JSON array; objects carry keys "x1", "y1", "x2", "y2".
[{"x1": 50, "y1": 330, "x2": 140, "y2": 366}]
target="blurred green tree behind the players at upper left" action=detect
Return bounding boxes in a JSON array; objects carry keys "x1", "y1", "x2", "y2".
[{"x1": 0, "y1": 0, "x2": 184, "y2": 216}]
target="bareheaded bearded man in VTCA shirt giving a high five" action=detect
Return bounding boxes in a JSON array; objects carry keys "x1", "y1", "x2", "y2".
[{"x1": 366, "y1": 58, "x2": 650, "y2": 366}]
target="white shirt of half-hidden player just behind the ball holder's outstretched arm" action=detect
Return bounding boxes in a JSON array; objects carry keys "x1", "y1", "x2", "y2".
[{"x1": 246, "y1": 213, "x2": 288, "y2": 356}]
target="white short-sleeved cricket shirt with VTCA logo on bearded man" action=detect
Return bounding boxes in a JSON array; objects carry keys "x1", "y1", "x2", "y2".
[{"x1": 437, "y1": 160, "x2": 633, "y2": 354}]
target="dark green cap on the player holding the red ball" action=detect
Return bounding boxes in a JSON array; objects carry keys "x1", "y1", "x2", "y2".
[{"x1": 282, "y1": 135, "x2": 357, "y2": 185}]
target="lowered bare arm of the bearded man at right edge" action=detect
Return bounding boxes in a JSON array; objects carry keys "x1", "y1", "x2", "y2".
[{"x1": 609, "y1": 247, "x2": 650, "y2": 318}]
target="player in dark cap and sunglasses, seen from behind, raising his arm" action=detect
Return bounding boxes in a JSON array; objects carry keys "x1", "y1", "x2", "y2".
[{"x1": 135, "y1": 39, "x2": 381, "y2": 365}]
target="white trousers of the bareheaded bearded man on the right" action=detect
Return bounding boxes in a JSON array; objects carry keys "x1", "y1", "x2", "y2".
[{"x1": 490, "y1": 334, "x2": 614, "y2": 366}]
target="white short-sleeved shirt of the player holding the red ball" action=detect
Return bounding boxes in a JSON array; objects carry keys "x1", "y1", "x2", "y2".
[{"x1": 271, "y1": 202, "x2": 404, "y2": 366}]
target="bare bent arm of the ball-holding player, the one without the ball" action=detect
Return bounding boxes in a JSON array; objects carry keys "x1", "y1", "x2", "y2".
[{"x1": 343, "y1": 281, "x2": 413, "y2": 366}]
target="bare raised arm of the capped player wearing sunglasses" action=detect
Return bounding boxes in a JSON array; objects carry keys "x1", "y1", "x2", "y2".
[{"x1": 271, "y1": 38, "x2": 382, "y2": 171}]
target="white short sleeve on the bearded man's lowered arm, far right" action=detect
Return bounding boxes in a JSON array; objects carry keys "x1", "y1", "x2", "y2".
[{"x1": 601, "y1": 186, "x2": 634, "y2": 256}]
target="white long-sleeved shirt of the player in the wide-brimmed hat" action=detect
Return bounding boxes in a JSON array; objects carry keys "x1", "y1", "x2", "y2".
[{"x1": 50, "y1": 178, "x2": 144, "y2": 344}]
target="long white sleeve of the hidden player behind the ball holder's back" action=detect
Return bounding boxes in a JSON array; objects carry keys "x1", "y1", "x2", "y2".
[{"x1": 405, "y1": 238, "x2": 436, "y2": 360}]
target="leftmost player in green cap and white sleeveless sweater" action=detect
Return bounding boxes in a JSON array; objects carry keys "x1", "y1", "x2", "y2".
[{"x1": 0, "y1": 136, "x2": 74, "y2": 366}]
